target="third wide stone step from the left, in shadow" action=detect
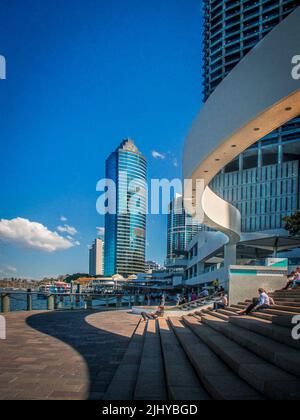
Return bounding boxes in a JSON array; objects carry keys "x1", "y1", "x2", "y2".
[{"x1": 158, "y1": 319, "x2": 211, "y2": 401}]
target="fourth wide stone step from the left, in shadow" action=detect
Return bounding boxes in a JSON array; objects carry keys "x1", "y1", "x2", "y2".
[{"x1": 170, "y1": 317, "x2": 263, "y2": 401}]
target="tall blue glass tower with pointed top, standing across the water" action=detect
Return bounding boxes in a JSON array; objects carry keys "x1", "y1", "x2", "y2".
[{"x1": 104, "y1": 139, "x2": 147, "y2": 277}]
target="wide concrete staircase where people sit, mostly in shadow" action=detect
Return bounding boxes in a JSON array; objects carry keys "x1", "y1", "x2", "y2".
[{"x1": 104, "y1": 290, "x2": 300, "y2": 401}]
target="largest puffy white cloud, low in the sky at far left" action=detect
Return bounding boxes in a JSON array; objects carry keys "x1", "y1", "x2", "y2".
[{"x1": 0, "y1": 217, "x2": 77, "y2": 252}]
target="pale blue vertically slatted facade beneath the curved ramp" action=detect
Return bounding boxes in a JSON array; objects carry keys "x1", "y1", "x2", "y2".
[{"x1": 212, "y1": 161, "x2": 299, "y2": 232}]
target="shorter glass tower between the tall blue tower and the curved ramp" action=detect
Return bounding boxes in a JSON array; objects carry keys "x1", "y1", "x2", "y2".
[{"x1": 167, "y1": 196, "x2": 202, "y2": 260}]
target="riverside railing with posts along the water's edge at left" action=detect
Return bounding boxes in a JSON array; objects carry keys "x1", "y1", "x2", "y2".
[{"x1": 0, "y1": 291, "x2": 144, "y2": 313}]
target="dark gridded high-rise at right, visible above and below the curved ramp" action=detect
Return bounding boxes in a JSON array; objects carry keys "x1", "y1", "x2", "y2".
[{"x1": 203, "y1": 0, "x2": 300, "y2": 232}]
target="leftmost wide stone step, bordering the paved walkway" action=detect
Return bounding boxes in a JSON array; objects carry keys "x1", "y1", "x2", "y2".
[{"x1": 103, "y1": 323, "x2": 145, "y2": 401}]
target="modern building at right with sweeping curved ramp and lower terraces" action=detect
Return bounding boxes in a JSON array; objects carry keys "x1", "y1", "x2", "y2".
[{"x1": 183, "y1": 7, "x2": 300, "y2": 292}]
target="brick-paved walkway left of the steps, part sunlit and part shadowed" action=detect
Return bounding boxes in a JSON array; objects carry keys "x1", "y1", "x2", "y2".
[{"x1": 0, "y1": 311, "x2": 139, "y2": 400}]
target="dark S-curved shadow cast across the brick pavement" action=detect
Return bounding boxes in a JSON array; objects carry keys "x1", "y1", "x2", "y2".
[{"x1": 26, "y1": 310, "x2": 135, "y2": 400}]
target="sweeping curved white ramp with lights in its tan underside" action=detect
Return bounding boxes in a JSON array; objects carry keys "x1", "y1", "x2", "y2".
[{"x1": 183, "y1": 7, "x2": 300, "y2": 244}]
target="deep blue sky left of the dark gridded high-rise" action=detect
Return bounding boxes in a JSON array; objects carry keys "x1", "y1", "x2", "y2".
[{"x1": 0, "y1": 0, "x2": 202, "y2": 278}]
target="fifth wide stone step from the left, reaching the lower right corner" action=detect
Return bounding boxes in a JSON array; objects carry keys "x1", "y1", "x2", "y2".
[{"x1": 184, "y1": 317, "x2": 300, "y2": 400}]
